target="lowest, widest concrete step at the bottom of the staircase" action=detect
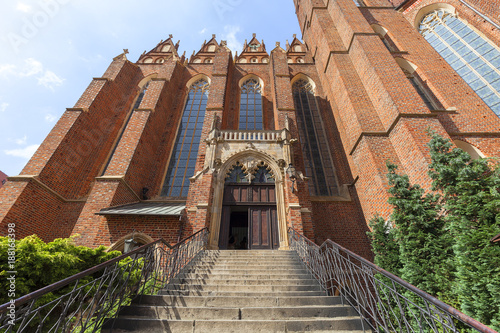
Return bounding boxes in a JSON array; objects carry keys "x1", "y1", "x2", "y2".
[{"x1": 101, "y1": 317, "x2": 367, "y2": 333}]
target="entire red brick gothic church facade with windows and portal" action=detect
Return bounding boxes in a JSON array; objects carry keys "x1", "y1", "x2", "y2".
[{"x1": 0, "y1": 0, "x2": 500, "y2": 257}]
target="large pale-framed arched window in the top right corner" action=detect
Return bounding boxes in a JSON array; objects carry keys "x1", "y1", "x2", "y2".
[{"x1": 419, "y1": 9, "x2": 500, "y2": 116}]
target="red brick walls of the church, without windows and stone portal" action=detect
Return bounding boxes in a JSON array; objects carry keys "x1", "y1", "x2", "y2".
[{"x1": 0, "y1": 0, "x2": 500, "y2": 258}]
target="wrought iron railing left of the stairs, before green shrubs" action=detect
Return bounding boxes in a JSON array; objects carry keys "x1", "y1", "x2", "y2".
[{"x1": 0, "y1": 228, "x2": 208, "y2": 333}]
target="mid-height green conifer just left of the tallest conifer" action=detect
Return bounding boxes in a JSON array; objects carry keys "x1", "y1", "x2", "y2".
[{"x1": 387, "y1": 163, "x2": 453, "y2": 302}]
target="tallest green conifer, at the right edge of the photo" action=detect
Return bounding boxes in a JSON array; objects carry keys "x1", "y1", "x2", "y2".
[{"x1": 429, "y1": 134, "x2": 500, "y2": 330}]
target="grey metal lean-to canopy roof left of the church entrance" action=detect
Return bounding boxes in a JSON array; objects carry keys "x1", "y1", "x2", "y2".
[{"x1": 96, "y1": 202, "x2": 186, "y2": 216}]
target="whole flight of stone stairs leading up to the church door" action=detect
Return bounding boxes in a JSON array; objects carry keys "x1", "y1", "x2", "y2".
[{"x1": 102, "y1": 250, "x2": 367, "y2": 333}]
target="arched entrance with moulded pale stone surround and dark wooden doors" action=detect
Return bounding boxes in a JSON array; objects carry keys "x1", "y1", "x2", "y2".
[{"x1": 208, "y1": 149, "x2": 288, "y2": 250}]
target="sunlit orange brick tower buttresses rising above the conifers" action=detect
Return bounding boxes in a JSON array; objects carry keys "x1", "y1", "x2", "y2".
[{"x1": 296, "y1": 0, "x2": 500, "y2": 228}]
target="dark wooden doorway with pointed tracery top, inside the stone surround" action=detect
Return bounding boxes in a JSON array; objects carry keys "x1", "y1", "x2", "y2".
[{"x1": 218, "y1": 162, "x2": 280, "y2": 249}]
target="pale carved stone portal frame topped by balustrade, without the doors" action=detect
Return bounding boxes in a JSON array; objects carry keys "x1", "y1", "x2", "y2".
[{"x1": 204, "y1": 129, "x2": 295, "y2": 249}]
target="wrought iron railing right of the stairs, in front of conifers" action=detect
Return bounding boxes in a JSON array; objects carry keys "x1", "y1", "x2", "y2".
[{"x1": 289, "y1": 228, "x2": 496, "y2": 333}]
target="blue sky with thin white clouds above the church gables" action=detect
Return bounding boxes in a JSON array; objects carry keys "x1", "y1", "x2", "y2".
[{"x1": 0, "y1": 0, "x2": 300, "y2": 176}]
